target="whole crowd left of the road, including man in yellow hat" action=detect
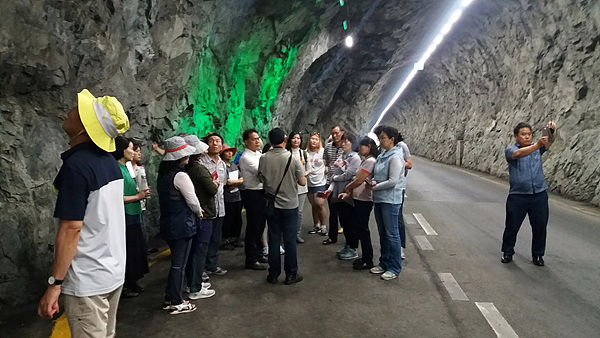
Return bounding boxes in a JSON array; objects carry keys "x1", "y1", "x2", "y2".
[{"x1": 38, "y1": 90, "x2": 407, "y2": 336}]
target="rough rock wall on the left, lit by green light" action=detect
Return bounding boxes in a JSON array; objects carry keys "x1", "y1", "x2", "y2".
[{"x1": 0, "y1": 0, "x2": 337, "y2": 317}]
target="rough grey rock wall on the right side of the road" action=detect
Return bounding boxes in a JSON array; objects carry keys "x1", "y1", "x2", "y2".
[{"x1": 383, "y1": 0, "x2": 600, "y2": 205}]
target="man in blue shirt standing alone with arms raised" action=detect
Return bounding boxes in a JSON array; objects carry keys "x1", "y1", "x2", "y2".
[{"x1": 502, "y1": 121, "x2": 556, "y2": 266}]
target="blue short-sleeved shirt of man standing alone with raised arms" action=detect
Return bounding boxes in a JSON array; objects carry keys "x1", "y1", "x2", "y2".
[{"x1": 504, "y1": 143, "x2": 548, "y2": 195}]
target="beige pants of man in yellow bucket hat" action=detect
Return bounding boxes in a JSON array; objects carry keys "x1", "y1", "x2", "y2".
[{"x1": 64, "y1": 285, "x2": 123, "y2": 338}]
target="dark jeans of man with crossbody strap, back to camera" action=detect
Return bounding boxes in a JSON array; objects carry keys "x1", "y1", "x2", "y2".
[{"x1": 267, "y1": 208, "x2": 298, "y2": 278}]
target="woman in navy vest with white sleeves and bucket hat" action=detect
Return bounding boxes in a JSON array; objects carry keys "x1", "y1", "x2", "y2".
[{"x1": 157, "y1": 136, "x2": 202, "y2": 314}]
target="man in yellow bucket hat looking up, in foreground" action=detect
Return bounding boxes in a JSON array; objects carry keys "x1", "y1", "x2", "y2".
[{"x1": 38, "y1": 89, "x2": 129, "y2": 337}]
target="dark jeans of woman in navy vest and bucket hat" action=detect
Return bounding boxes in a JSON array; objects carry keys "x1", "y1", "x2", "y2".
[{"x1": 165, "y1": 237, "x2": 192, "y2": 305}]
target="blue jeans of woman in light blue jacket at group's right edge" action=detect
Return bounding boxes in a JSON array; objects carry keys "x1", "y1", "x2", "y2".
[{"x1": 375, "y1": 203, "x2": 402, "y2": 274}]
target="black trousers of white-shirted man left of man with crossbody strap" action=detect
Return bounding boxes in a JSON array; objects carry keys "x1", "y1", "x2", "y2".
[{"x1": 241, "y1": 190, "x2": 267, "y2": 264}]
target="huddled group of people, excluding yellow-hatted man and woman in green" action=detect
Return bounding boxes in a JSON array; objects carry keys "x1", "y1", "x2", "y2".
[{"x1": 148, "y1": 125, "x2": 412, "y2": 314}]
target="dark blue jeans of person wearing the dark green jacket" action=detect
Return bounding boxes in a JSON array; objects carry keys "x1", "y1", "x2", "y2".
[{"x1": 185, "y1": 219, "x2": 213, "y2": 292}]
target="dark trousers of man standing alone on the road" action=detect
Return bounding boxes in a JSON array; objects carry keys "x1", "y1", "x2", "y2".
[{"x1": 502, "y1": 191, "x2": 550, "y2": 256}]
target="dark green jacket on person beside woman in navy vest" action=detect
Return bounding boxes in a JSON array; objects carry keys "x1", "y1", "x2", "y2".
[{"x1": 185, "y1": 162, "x2": 217, "y2": 219}]
